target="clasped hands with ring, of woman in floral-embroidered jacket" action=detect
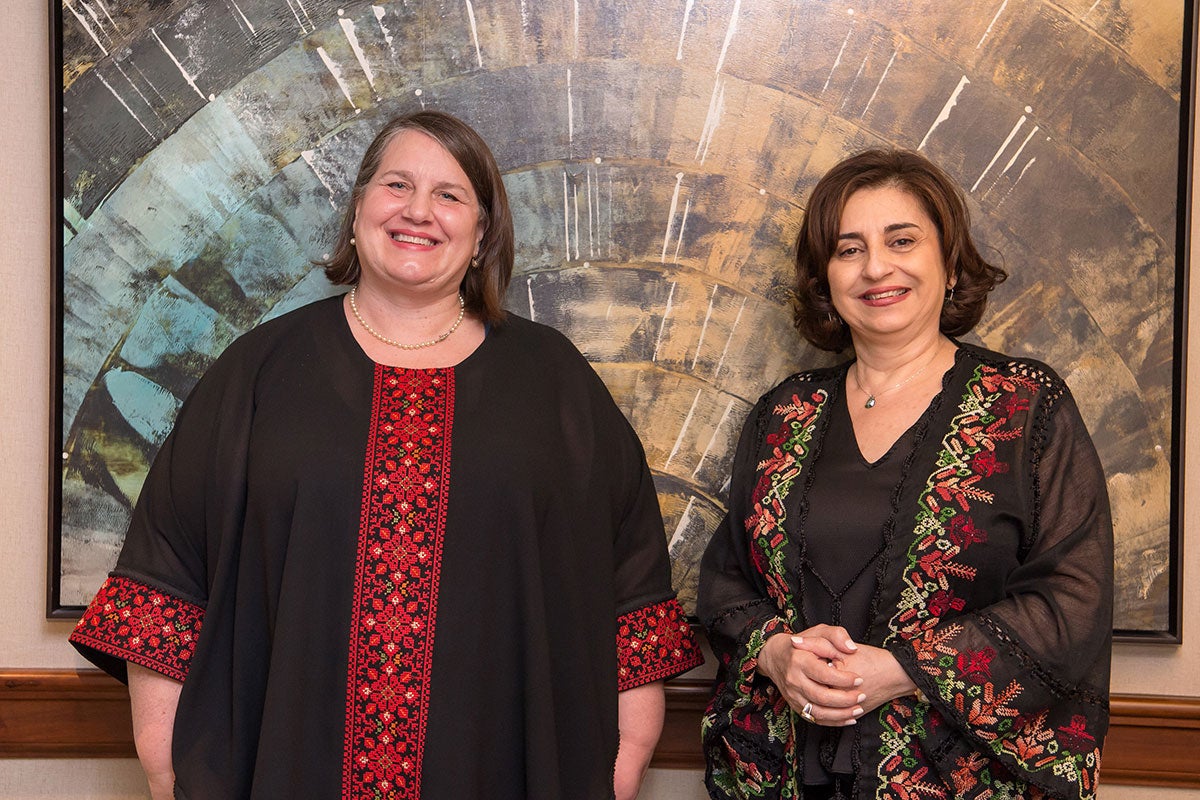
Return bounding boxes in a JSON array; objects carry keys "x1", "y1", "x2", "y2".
[{"x1": 758, "y1": 625, "x2": 916, "y2": 727}]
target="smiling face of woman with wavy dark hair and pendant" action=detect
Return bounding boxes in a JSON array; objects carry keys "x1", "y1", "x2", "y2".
[{"x1": 828, "y1": 185, "x2": 948, "y2": 342}]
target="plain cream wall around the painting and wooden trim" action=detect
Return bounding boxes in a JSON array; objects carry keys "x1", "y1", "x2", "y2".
[{"x1": 0, "y1": 0, "x2": 1200, "y2": 800}]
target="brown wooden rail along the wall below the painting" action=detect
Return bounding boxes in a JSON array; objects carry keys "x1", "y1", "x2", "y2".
[{"x1": 0, "y1": 669, "x2": 1200, "y2": 788}]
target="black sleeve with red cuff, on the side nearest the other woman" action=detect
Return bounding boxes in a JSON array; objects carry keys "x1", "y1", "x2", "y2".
[{"x1": 614, "y1": 411, "x2": 704, "y2": 691}]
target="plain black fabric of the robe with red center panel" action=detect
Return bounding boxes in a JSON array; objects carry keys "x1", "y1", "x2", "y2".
[{"x1": 75, "y1": 297, "x2": 691, "y2": 800}]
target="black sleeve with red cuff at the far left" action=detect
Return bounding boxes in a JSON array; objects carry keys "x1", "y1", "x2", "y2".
[{"x1": 70, "y1": 347, "x2": 252, "y2": 681}]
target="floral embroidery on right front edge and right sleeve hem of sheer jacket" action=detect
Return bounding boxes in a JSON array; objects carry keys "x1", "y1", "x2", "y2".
[{"x1": 876, "y1": 366, "x2": 1099, "y2": 799}]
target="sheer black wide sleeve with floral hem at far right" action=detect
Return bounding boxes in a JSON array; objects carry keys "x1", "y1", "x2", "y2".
[{"x1": 889, "y1": 387, "x2": 1112, "y2": 798}]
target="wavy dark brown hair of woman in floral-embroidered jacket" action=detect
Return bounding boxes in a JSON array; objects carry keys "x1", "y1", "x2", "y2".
[{"x1": 792, "y1": 150, "x2": 1008, "y2": 353}]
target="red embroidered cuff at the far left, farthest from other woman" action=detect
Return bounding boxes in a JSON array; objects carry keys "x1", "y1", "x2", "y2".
[{"x1": 71, "y1": 576, "x2": 204, "y2": 680}]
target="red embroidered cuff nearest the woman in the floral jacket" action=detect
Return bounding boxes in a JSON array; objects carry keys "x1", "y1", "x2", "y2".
[{"x1": 617, "y1": 599, "x2": 704, "y2": 692}]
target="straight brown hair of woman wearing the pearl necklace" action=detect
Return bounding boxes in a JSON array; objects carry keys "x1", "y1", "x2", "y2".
[{"x1": 317, "y1": 110, "x2": 514, "y2": 323}]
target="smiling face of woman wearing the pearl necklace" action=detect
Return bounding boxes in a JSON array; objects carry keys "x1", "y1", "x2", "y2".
[{"x1": 354, "y1": 131, "x2": 484, "y2": 295}]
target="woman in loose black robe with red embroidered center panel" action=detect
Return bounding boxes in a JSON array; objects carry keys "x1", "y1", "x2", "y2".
[{"x1": 72, "y1": 112, "x2": 700, "y2": 800}]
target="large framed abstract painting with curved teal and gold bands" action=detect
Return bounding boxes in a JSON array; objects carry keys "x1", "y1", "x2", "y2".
[{"x1": 50, "y1": 0, "x2": 1192, "y2": 640}]
